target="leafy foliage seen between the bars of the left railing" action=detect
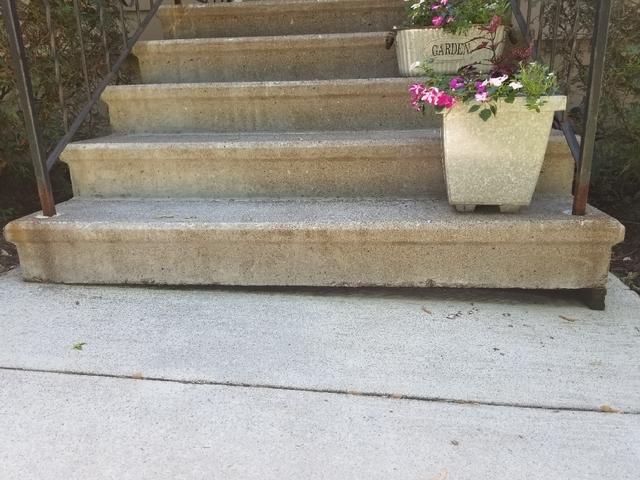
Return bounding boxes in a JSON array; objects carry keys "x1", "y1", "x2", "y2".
[{"x1": 0, "y1": 0, "x2": 127, "y2": 176}]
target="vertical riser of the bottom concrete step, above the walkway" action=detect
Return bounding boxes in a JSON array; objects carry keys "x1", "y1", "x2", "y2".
[{"x1": 10, "y1": 230, "x2": 610, "y2": 288}]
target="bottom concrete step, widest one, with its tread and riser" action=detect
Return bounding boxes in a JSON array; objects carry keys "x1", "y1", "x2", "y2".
[{"x1": 5, "y1": 196, "x2": 624, "y2": 288}]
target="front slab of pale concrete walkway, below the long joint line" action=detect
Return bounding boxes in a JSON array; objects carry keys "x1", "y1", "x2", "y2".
[{"x1": 0, "y1": 371, "x2": 640, "y2": 480}]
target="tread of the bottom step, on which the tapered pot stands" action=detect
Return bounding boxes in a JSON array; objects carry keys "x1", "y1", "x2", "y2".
[{"x1": 7, "y1": 195, "x2": 622, "y2": 243}]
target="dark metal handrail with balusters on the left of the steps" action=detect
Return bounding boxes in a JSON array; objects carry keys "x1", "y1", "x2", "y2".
[{"x1": 0, "y1": 0, "x2": 163, "y2": 217}]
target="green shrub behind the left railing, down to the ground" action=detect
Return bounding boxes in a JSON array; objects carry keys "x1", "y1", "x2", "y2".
[{"x1": 0, "y1": 0, "x2": 127, "y2": 222}]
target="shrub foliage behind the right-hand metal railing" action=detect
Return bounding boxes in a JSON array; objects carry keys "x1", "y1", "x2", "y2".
[{"x1": 545, "y1": 0, "x2": 640, "y2": 204}]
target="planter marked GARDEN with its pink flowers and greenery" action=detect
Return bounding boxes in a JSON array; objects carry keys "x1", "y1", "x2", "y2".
[{"x1": 395, "y1": 0, "x2": 510, "y2": 76}]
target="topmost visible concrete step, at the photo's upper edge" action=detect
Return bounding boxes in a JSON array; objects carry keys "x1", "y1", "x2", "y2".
[{"x1": 158, "y1": 0, "x2": 405, "y2": 39}]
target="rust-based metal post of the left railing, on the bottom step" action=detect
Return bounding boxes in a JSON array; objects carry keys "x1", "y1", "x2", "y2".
[{"x1": 0, "y1": 0, "x2": 56, "y2": 217}]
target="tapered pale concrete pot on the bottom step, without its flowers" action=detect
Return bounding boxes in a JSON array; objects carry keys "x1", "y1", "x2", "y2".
[{"x1": 442, "y1": 95, "x2": 566, "y2": 212}]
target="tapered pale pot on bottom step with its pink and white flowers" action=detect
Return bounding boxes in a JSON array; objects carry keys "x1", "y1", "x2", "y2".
[{"x1": 409, "y1": 62, "x2": 566, "y2": 212}]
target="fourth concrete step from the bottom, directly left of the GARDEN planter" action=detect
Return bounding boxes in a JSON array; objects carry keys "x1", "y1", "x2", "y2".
[{"x1": 134, "y1": 32, "x2": 399, "y2": 83}]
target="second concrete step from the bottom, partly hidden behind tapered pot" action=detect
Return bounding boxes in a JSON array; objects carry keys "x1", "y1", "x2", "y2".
[{"x1": 61, "y1": 129, "x2": 574, "y2": 198}]
